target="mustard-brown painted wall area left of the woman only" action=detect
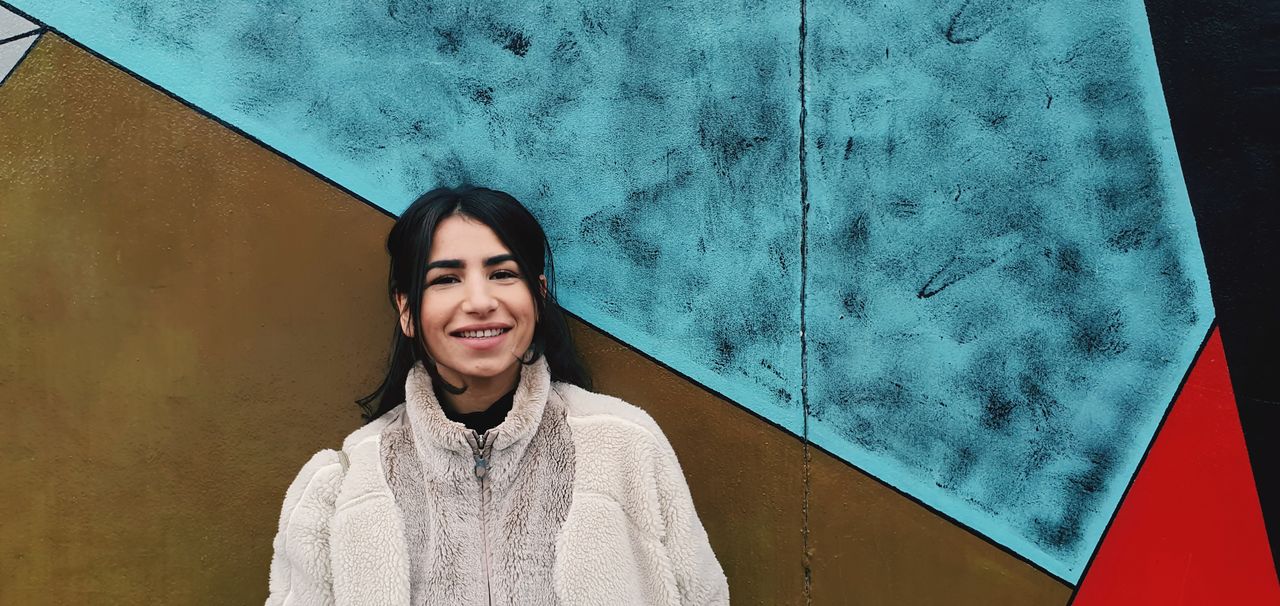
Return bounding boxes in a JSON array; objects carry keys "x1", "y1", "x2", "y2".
[{"x1": 0, "y1": 35, "x2": 390, "y2": 605}]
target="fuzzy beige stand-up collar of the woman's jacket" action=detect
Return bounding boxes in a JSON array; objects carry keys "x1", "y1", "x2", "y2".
[{"x1": 404, "y1": 356, "x2": 552, "y2": 455}]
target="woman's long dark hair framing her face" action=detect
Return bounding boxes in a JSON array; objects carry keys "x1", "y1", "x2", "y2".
[{"x1": 356, "y1": 186, "x2": 591, "y2": 423}]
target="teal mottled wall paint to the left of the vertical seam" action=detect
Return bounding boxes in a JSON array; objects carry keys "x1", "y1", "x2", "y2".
[{"x1": 14, "y1": 0, "x2": 803, "y2": 433}]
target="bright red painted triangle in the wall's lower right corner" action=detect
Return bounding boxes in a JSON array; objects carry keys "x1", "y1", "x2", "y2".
[{"x1": 1073, "y1": 329, "x2": 1280, "y2": 606}]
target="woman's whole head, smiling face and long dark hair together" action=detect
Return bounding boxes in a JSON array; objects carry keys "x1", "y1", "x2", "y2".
[{"x1": 360, "y1": 187, "x2": 591, "y2": 420}]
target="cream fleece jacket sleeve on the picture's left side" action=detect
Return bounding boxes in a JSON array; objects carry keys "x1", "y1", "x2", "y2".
[{"x1": 266, "y1": 450, "x2": 342, "y2": 606}]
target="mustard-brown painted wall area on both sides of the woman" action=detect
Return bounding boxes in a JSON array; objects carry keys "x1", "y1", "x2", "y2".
[{"x1": 0, "y1": 33, "x2": 1068, "y2": 605}]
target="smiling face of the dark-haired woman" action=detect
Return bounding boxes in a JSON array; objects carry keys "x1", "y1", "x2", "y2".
[{"x1": 399, "y1": 215, "x2": 541, "y2": 386}]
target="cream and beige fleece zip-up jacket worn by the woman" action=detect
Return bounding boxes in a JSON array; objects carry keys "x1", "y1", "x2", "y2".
[{"x1": 266, "y1": 360, "x2": 728, "y2": 606}]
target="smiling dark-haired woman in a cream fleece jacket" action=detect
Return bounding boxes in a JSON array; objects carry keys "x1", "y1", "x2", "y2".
[{"x1": 268, "y1": 187, "x2": 728, "y2": 606}]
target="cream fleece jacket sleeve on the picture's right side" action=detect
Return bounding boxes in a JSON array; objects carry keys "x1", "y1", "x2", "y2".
[{"x1": 654, "y1": 432, "x2": 728, "y2": 606}]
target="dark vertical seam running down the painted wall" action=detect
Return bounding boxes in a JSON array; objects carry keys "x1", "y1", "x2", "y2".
[{"x1": 799, "y1": 0, "x2": 813, "y2": 606}]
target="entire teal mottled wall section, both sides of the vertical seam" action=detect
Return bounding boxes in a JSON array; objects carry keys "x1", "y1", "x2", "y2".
[{"x1": 7, "y1": 0, "x2": 1213, "y2": 582}]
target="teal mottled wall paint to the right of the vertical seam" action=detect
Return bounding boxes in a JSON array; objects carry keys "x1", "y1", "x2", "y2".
[{"x1": 806, "y1": 0, "x2": 1213, "y2": 582}]
